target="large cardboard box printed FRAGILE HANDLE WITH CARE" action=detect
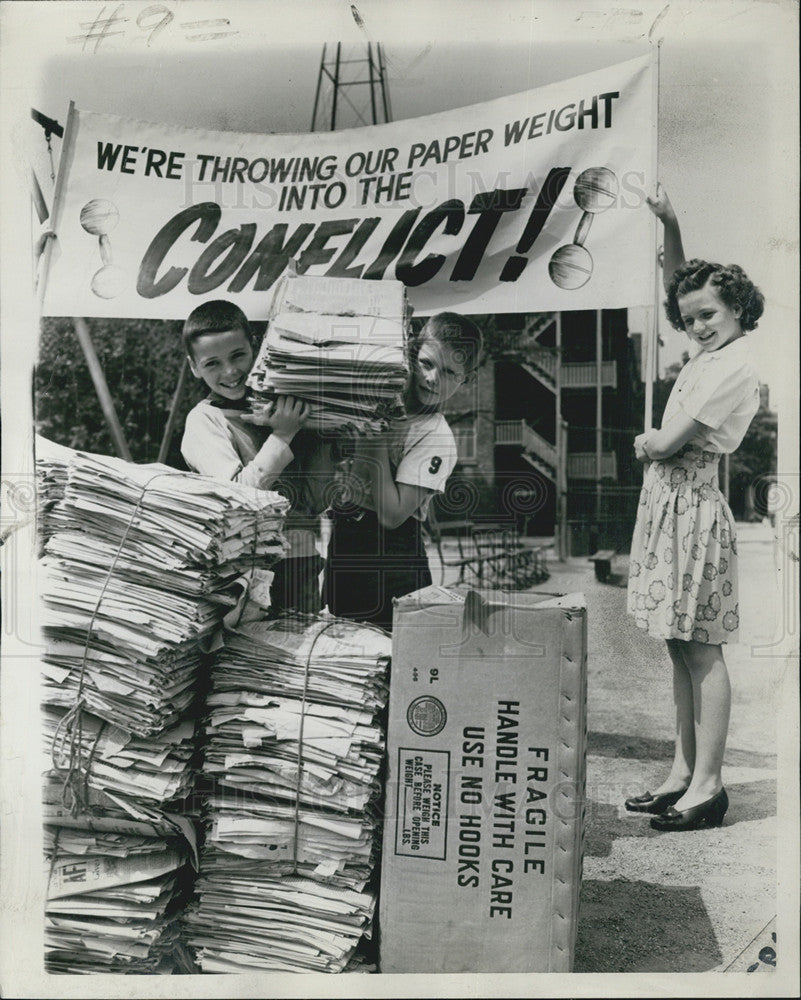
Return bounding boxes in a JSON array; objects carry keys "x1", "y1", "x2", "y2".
[{"x1": 379, "y1": 586, "x2": 587, "y2": 973}]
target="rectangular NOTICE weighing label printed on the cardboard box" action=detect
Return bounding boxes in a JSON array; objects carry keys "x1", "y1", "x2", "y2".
[{"x1": 395, "y1": 747, "x2": 451, "y2": 861}]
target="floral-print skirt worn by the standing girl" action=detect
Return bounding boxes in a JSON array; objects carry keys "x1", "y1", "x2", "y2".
[{"x1": 628, "y1": 445, "x2": 740, "y2": 645}]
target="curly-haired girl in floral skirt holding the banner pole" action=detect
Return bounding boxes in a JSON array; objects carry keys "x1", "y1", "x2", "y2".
[{"x1": 626, "y1": 193, "x2": 764, "y2": 830}]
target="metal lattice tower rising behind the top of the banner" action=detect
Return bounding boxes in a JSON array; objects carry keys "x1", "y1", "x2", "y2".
[{"x1": 311, "y1": 42, "x2": 392, "y2": 132}]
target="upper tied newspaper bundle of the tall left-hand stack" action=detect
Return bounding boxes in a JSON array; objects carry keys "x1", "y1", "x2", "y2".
[{"x1": 40, "y1": 442, "x2": 288, "y2": 735}]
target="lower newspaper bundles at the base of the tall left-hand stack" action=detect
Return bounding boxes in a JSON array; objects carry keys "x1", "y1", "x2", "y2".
[{"x1": 42, "y1": 707, "x2": 197, "y2": 973}]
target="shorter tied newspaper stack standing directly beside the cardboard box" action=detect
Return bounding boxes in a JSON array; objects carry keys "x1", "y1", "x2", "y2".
[{"x1": 186, "y1": 616, "x2": 391, "y2": 972}]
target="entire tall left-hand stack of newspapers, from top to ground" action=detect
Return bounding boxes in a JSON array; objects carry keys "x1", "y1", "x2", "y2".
[{"x1": 37, "y1": 441, "x2": 288, "y2": 973}]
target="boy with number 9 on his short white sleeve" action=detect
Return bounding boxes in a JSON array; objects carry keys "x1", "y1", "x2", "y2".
[{"x1": 324, "y1": 313, "x2": 482, "y2": 631}]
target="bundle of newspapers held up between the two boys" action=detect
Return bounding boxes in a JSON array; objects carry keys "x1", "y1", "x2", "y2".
[{"x1": 249, "y1": 275, "x2": 411, "y2": 431}]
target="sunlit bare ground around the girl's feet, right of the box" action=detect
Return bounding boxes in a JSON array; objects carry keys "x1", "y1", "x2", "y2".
[{"x1": 424, "y1": 522, "x2": 788, "y2": 974}]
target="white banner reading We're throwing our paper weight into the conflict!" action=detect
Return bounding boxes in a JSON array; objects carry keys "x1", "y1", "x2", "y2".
[{"x1": 41, "y1": 57, "x2": 656, "y2": 320}]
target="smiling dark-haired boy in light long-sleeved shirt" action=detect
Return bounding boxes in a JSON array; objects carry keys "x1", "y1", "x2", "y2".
[{"x1": 181, "y1": 299, "x2": 322, "y2": 615}]
